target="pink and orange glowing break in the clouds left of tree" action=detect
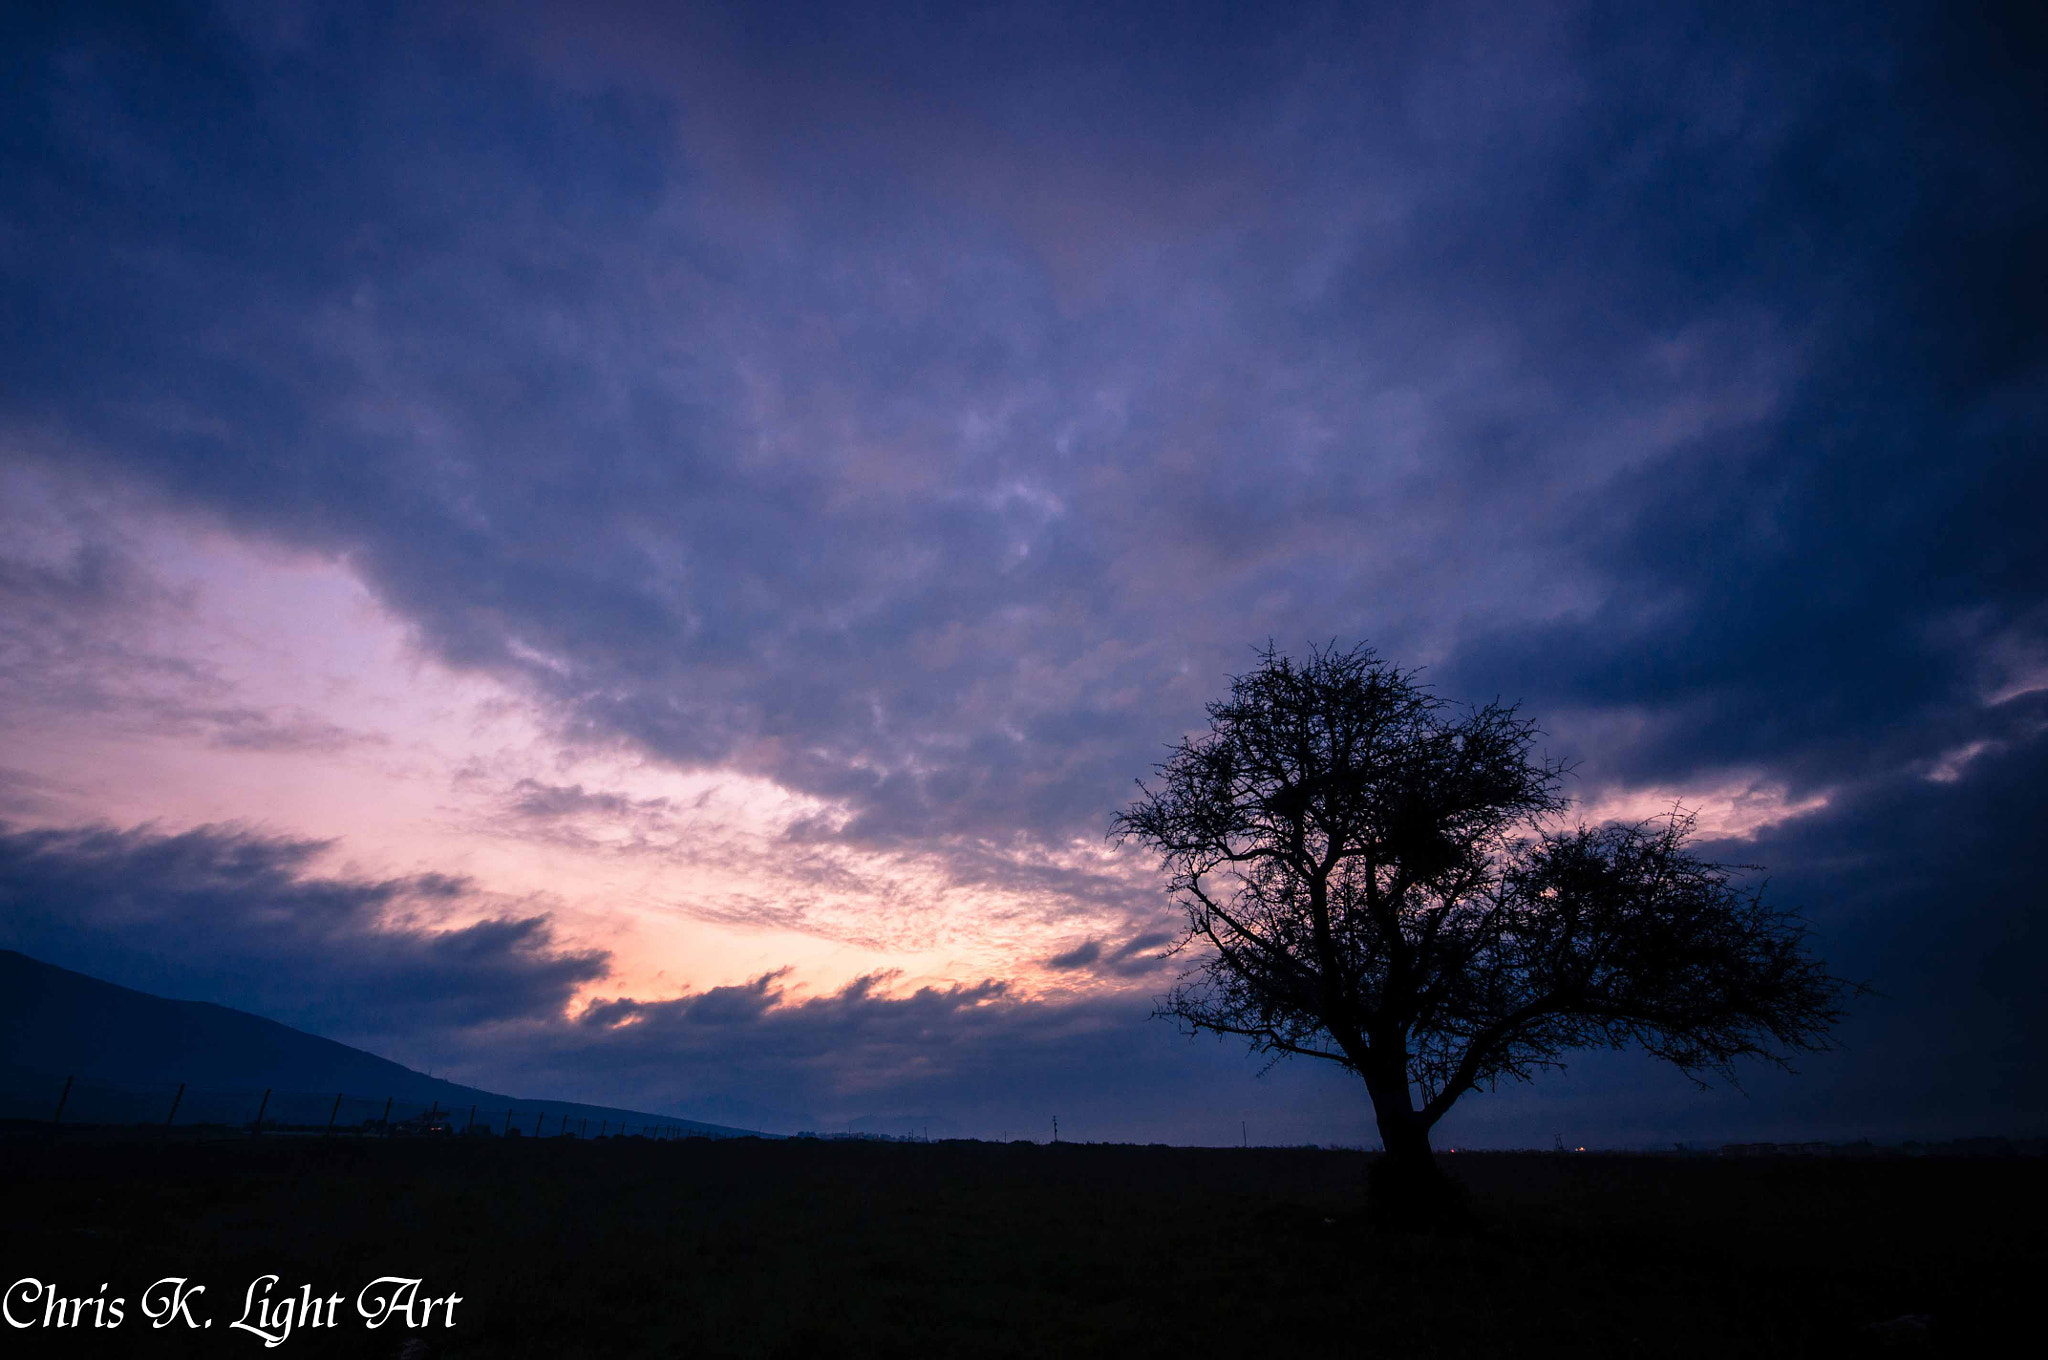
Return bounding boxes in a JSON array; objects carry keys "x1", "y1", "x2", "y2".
[{"x1": 4, "y1": 489, "x2": 1163, "y2": 1004}]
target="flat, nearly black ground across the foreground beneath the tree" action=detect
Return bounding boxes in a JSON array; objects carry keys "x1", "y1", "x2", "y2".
[{"x1": 0, "y1": 1135, "x2": 2048, "y2": 1360}]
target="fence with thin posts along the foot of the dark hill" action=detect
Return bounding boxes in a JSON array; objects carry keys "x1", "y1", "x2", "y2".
[{"x1": 0, "y1": 1075, "x2": 743, "y2": 1139}]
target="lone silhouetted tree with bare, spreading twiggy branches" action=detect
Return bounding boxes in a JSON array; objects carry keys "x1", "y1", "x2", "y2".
[{"x1": 1110, "y1": 645, "x2": 1851, "y2": 1225}]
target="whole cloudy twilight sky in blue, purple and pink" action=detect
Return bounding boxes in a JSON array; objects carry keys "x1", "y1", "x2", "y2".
[{"x1": 0, "y1": 0, "x2": 2048, "y2": 1147}]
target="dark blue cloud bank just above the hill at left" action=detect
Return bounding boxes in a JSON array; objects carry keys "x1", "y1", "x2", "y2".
[{"x1": 0, "y1": 827, "x2": 606, "y2": 1049}]
